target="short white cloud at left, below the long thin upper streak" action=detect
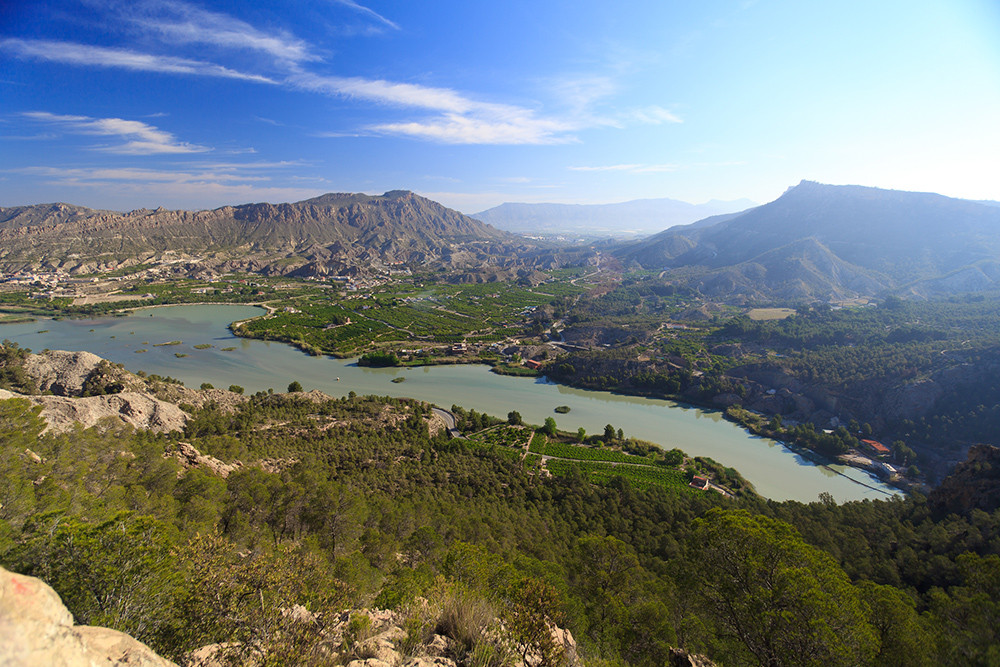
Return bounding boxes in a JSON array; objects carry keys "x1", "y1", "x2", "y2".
[{"x1": 21, "y1": 111, "x2": 211, "y2": 155}]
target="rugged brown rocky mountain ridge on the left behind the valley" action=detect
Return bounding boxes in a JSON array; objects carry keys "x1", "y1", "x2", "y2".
[{"x1": 0, "y1": 191, "x2": 540, "y2": 274}]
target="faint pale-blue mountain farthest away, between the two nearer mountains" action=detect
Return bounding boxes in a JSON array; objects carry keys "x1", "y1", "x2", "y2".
[{"x1": 472, "y1": 199, "x2": 755, "y2": 237}]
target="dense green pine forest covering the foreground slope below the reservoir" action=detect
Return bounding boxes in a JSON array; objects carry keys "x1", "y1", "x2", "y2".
[{"x1": 0, "y1": 393, "x2": 1000, "y2": 665}]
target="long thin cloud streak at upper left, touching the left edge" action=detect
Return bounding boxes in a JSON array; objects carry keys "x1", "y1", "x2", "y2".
[{"x1": 0, "y1": 38, "x2": 275, "y2": 83}]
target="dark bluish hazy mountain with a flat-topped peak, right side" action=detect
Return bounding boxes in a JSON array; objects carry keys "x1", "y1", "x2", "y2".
[{"x1": 616, "y1": 181, "x2": 1000, "y2": 298}]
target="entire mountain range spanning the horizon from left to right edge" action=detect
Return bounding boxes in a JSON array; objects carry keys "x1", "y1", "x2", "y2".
[{"x1": 0, "y1": 181, "x2": 1000, "y2": 302}]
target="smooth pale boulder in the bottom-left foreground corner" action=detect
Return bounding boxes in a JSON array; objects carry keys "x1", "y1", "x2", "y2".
[{"x1": 0, "y1": 567, "x2": 176, "y2": 667}]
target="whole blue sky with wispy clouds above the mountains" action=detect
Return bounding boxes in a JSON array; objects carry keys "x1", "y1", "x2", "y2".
[{"x1": 0, "y1": 0, "x2": 1000, "y2": 213}]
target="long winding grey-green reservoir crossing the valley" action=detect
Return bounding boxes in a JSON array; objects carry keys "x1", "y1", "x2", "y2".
[{"x1": 0, "y1": 305, "x2": 898, "y2": 502}]
